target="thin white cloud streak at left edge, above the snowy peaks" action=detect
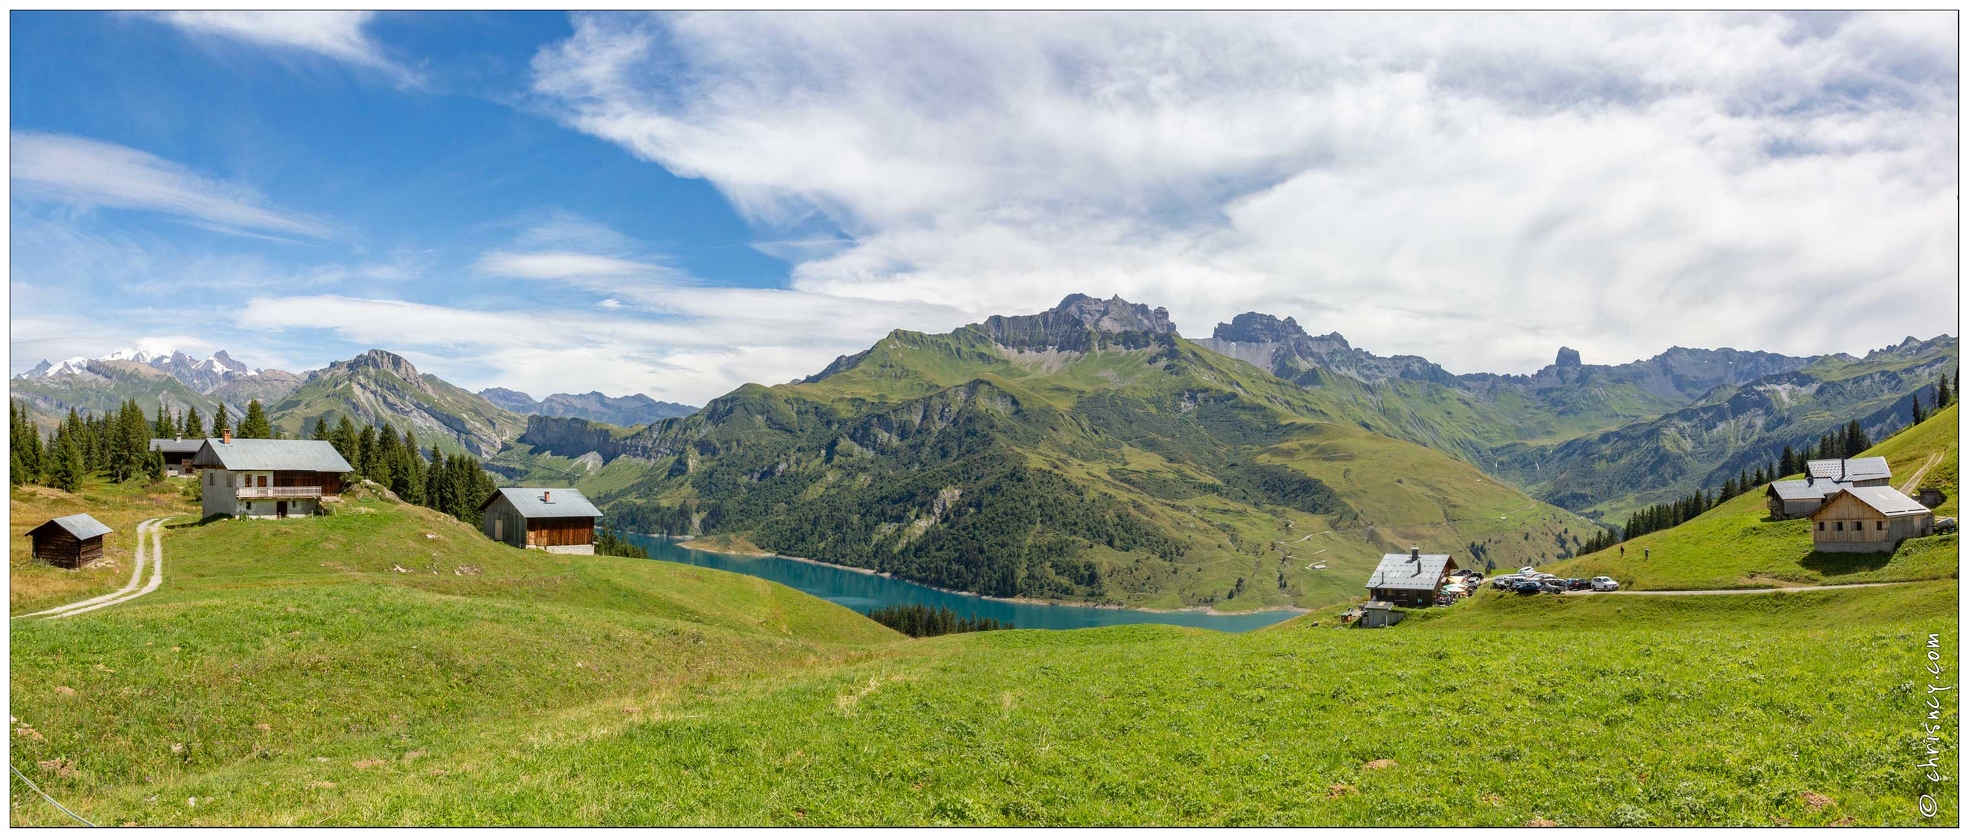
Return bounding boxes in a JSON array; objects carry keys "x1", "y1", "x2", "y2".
[{"x1": 12, "y1": 132, "x2": 329, "y2": 238}]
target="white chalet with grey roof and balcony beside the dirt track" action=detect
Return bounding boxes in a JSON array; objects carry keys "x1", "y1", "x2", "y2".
[{"x1": 191, "y1": 431, "x2": 354, "y2": 517}]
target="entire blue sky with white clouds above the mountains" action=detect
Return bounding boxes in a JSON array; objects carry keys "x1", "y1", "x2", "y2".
[{"x1": 10, "y1": 12, "x2": 1957, "y2": 403}]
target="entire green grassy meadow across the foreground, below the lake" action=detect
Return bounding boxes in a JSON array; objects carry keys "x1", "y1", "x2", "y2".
[{"x1": 10, "y1": 481, "x2": 1959, "y2": 826}]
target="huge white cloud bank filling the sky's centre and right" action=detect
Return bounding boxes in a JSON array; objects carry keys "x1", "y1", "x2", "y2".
[{"x1": 534, "y1": 14, "x2": 1957, "y2": 372}]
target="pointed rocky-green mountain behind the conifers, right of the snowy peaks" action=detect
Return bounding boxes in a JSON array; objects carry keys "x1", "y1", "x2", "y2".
[{"x1": 268, "y1": 350, "x2": 526, "y2": 458}]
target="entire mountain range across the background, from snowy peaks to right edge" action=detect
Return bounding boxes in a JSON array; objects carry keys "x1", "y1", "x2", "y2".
[{"x1": 10, "y1": 295, "x2": 1959, "y2": 610}]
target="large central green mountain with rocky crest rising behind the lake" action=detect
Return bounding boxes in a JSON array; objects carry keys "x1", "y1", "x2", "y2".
[{"x1": 543, "y1": 295, "x2": 1587, "y2": 610}]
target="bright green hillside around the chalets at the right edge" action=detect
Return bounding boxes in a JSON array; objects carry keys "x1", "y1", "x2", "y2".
[{"x1": 1548, "y1": 405, "x2": 1961, "y2": 590}]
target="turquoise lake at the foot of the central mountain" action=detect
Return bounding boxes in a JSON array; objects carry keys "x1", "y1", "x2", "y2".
[{"x1": 622, "y1": 533, "x2": 1296, "y2": 631}]
